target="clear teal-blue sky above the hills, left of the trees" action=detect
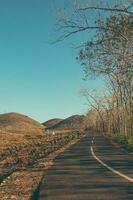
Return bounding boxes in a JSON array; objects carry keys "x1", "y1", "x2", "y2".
[{"x1": 0, "y1": 0, "x2": 104, "y2": 122}]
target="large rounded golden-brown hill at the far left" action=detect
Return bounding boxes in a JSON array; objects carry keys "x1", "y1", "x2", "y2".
[{"x1": 0, "y1": 113, "x2": 44, "y2": 134}]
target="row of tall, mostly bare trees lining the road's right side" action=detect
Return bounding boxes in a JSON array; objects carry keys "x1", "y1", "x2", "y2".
[{"x1": 57, "y1": 0, "x2": 133, "y2": 150}]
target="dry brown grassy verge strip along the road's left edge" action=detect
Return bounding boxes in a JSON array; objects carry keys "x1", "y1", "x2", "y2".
[{"x1": 0, "y1": 136, "x2": 83, "y2": 200}]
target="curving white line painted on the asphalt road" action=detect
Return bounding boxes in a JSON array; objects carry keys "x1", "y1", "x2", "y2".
[{"x1": 91, "y1": 140, "x2": 133, "y2": 183}]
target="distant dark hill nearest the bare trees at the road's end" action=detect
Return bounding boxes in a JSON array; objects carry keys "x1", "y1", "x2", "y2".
[{"x1": 47, "y1": 115, "x2": 85, "y2": 130}]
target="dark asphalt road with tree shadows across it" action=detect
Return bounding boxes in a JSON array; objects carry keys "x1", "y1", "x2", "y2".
[{"x1": 38, "y1": 135, "x2": 133, "y2": 200}]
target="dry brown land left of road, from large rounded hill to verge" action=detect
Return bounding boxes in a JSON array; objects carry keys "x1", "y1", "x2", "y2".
[{"x1": 0, "y1": 113, "x2": 82, "y2": 200}]
